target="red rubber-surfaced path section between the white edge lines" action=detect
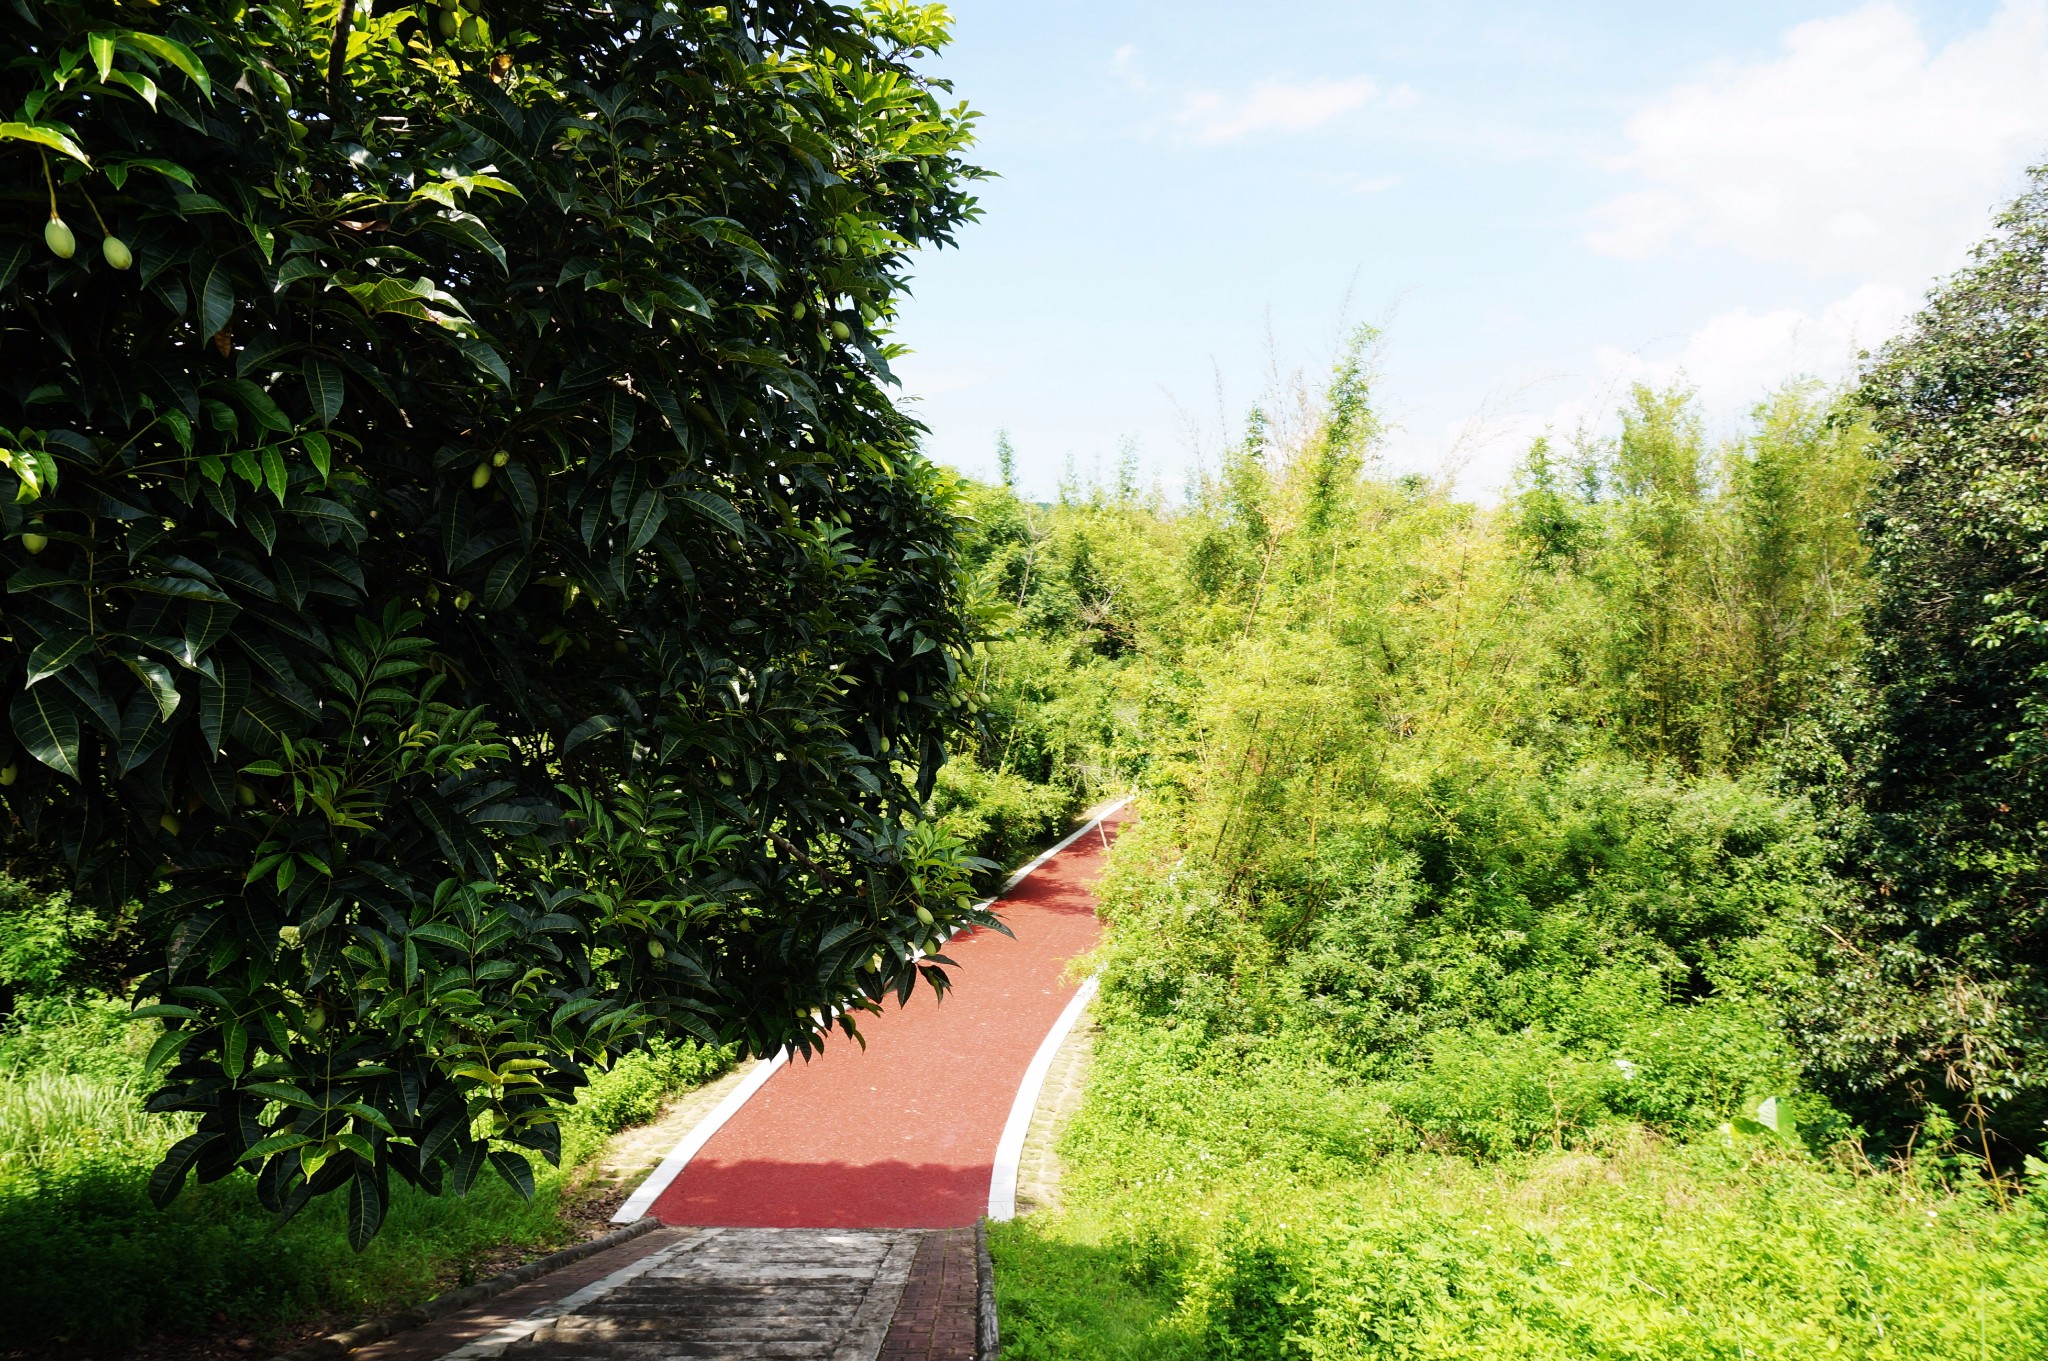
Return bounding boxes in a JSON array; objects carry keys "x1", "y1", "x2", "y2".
[{"x1": 651, "y1": 815, "x2": 1122, "y2": 1228}]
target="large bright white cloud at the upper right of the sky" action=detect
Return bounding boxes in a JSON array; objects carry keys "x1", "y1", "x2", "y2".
[{"x1": 1587, "y1": 0, "x2": 2048, "y2": 278}]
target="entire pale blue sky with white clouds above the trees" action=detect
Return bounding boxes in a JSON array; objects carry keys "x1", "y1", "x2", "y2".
[{"x1": 897, "y1": 0, "x2": 2048, "y2": 497}]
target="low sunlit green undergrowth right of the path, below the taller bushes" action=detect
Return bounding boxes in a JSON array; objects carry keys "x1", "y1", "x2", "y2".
[{"x1": 991, "y1": 1025, "x2": 2048, "y2": 1361}]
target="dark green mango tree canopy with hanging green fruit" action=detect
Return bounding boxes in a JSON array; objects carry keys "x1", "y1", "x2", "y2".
[{"x1": 0, "y1": 0, "x2": 979, "y2": 1242}]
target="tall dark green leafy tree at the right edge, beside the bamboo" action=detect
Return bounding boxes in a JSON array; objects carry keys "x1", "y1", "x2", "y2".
[{"x1": 1804, "y1": 161, "x2": 2048, "y2": 1165}]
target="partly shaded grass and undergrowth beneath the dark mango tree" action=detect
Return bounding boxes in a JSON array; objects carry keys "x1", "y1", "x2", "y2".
[{"x1": 0, "y1": 1001, "x2": 731, "y2": 1355}]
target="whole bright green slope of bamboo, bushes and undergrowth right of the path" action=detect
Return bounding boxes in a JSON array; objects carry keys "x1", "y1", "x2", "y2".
[{"x1": 971, "y1": 212, "x2": 2048, "y2": 1359}]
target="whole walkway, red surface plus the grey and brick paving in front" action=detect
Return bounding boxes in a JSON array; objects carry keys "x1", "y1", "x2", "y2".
[{"x1": 339, "y1": 815, "x2": 1122, "y2": 1361}]
